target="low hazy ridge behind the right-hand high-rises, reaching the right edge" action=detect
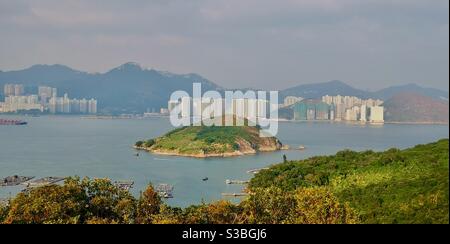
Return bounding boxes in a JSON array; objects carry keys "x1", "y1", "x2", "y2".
[{"x1": 281, "y1": 80, "x2": 449, "y2": 101}]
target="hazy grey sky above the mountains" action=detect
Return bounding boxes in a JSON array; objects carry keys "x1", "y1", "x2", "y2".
[{"x1": 0, "y1": 0, "x2": 449, "y2": 91}]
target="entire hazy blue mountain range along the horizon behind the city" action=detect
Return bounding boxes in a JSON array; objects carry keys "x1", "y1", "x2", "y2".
[{"x1": 0, "y1": 62, "x2": 449, "y2": 117}]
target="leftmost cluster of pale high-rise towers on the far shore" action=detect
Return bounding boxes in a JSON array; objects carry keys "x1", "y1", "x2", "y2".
[{"x1": 0, "y1": 84, "x2": 97, "y2": 114}]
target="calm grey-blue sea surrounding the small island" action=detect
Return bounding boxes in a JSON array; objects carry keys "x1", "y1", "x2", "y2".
[{"x1": 0, "y1": 116, "x2": 449, "y2": 206}]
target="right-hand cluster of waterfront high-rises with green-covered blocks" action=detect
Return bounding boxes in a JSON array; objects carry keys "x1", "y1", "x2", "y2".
[{"x1": 284, "y1": 95, "x2": 384, "y2": 123}]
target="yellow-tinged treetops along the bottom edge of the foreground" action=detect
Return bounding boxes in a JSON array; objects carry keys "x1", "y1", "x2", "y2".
[{"x1": 0, "y1": 178, "x2": 358, "y2": 224}]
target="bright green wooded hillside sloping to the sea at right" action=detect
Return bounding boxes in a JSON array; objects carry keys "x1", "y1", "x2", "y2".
[{"x1": 250, "y1": 140, "x2": 449, "y2": 223}]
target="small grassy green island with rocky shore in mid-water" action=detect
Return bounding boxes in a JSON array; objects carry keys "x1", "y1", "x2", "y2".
[{"x1": 134, "y1": 125, "x2": 283, "y2": 158}]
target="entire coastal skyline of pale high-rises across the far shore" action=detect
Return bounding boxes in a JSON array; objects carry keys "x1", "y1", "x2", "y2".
[{"x1": 0, "y1": 84, "x2": 384, "y2": 124}]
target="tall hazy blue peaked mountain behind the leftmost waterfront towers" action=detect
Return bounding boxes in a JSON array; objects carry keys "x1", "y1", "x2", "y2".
[{"x1": 0, "y1": 62, "x2": 221, "y2": 113}]
